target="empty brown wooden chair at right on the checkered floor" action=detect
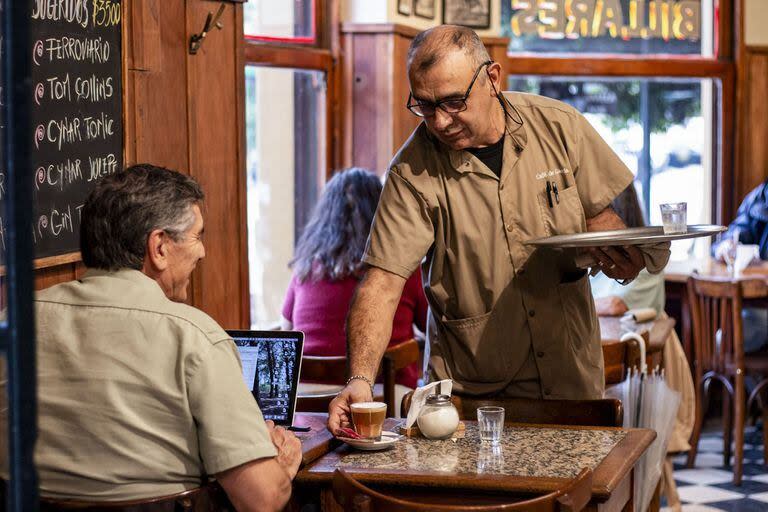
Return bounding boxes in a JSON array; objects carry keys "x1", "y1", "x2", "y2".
[{"x1": 687, "y1": 276, "x2": 768, "y2": 485}]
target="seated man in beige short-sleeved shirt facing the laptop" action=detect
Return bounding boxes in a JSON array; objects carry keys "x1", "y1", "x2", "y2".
[{"x1": 0, "y1": 165, "x2": 301, "y2": 510}]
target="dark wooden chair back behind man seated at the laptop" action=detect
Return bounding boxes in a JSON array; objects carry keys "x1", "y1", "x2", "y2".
[{"x1": 0, "y1": 482, "x2": 235, "y2": 512}]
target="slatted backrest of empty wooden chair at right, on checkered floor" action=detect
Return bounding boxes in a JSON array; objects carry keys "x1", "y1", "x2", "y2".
[{"x1": 687, "y1": 275, "x2": 744, "y2": 373}]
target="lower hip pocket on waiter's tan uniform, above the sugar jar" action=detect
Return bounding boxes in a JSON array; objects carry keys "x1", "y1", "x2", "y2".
[{"x1": 442, "y1": 313, "x2": 509, "y2": 383}]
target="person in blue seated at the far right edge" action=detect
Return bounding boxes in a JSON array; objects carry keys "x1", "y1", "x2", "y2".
[{"x1": 712, "y1": 179, "x2": 768, "y2": 352}]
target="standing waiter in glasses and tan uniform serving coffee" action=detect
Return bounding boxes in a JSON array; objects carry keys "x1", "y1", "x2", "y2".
[{"x1": 328, "y1": 25, "x2": 668, "y2": 432}]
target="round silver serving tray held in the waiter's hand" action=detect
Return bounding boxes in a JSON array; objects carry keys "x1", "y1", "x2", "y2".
[{"x1": 523, "y1": 224, "x2": 727, "y2": 248}]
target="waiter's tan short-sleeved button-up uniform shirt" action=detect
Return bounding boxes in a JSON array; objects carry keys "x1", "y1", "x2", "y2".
[{"x1": 364, "y1": 93, "x2": 633, "y2": 399}]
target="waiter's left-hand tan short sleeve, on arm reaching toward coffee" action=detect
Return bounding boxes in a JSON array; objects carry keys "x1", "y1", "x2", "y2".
[{"x1": 363, "y1": 168, "x2": 435, "y2": 279}]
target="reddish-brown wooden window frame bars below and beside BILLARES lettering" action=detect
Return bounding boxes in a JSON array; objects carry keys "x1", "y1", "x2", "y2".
[{"x1": 502, "y1": 0, "x2": 737, "y2": 223}]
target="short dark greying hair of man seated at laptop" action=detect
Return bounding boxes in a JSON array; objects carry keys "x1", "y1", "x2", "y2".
[{"x1": 80, "y1": 164, "x2": 203, "y2": 270}]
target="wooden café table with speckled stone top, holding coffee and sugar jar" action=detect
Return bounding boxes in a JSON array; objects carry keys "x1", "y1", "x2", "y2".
[{"x1": 294, "y1": 419, "x2": 656, "y2": 512}]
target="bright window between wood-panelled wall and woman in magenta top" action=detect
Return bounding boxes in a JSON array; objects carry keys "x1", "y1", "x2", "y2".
[{"x1": 243, "y1": 0, "x2": 335, "y2": 328}]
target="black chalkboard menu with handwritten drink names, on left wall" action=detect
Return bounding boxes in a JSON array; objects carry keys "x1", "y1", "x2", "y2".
[{"x1": 0, "y1": 0, "x2": 123, "y2": 264}]
